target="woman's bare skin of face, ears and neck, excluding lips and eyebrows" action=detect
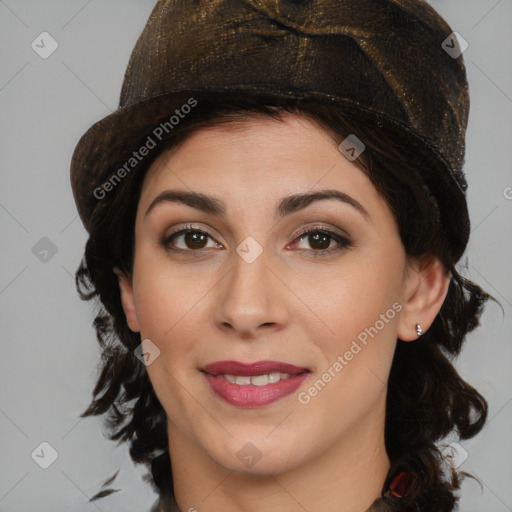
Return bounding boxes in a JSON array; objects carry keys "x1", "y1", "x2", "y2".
[{"x1": 115, "y1": 114, "x2": 449, "y2": 512}]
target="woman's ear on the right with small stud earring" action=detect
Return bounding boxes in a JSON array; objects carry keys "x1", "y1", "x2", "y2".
[{"x1": 397, "y1": 258, "x2": 451, "y2": 341}]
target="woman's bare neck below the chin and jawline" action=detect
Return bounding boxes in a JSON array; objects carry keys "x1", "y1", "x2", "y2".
[{"x1": 168, "y1": 401, "x2": 389, "y2": 512}]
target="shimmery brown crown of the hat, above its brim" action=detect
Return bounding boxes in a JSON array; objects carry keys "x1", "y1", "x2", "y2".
[{"x1": 120, "y1": 0, "x2": 469, "y2": 180}]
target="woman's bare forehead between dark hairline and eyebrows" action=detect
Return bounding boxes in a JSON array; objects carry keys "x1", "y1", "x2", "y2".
[{"x1": 141, "y1": 113, "x2": 365, "y2": 198}]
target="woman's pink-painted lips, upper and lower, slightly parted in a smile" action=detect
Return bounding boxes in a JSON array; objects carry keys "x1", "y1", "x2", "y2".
[{"x1": 201, "y1": 361, "x2": 310, "y2": 408}]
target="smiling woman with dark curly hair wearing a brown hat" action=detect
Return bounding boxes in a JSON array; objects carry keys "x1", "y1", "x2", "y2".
[{"x1": 71, "y1": 0, "x2": 489, "y2": 512}]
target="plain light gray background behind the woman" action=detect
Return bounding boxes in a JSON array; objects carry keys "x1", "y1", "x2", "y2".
[{"x1": 0, "y1": 0, "x2": 512, "y2": 512}]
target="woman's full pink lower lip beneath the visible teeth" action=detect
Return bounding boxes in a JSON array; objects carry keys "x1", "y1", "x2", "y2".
[{"x1": 203, "y1": 372, "x2": 309, "y2": 408}]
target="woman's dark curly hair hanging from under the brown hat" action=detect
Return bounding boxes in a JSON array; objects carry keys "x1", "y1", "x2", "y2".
[{"x1": 75, "y1": 95, "x2": 494, "y2": 512}]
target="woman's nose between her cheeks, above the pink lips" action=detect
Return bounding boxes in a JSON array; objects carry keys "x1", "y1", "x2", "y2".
[{"x1": 214, "y1": 251, "x2": 292, "y2": 339}]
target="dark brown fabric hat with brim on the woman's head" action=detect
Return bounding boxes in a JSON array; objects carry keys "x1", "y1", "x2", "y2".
[{"x1": 71, "y1": 0, "x2": 469, "y2": 259}]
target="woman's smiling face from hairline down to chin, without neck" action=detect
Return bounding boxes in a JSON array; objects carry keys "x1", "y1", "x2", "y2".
[{"x1": 117, "y1": 114, "x2": 428, "y2": 474}]
